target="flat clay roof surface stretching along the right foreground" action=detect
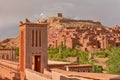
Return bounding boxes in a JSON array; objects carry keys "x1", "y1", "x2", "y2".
[{"x1": 52, "y1": 68, "x2": 120, "y2": 80}]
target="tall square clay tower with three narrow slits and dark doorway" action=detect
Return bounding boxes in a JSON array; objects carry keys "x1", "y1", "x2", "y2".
[{"x1": 20, "y1": 19, "x2": 47, "y2": 79}]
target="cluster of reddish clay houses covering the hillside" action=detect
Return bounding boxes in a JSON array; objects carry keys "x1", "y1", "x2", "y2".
[{"x1": 48, "y1": 23, "x2": 120, "y2": 52}]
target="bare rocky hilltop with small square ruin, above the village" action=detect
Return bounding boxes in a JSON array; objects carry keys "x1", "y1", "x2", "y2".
[{"x1": 37, "y1": 13, "x2": 105, "y2": 33}]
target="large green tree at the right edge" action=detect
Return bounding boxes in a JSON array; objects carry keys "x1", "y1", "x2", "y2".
[{"x1": 107, "y1": 47, "x2": 120, "y2": 74}]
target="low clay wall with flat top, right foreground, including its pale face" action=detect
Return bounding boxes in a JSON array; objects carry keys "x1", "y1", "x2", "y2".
[{"x1": 52, "y1": 69, "x2": 120, "y2": 80}]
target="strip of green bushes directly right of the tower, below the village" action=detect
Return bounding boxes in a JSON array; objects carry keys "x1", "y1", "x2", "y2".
[{"x1": 48, "y1": 46, "x2": 89, "y2": 64}]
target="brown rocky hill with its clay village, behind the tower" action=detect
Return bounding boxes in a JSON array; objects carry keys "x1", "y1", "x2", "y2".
[{"x1": 0, "y1": 13, "x2": 120, "y2": 52}]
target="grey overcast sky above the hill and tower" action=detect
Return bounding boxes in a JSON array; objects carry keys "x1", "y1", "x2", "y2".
[{"x1": 0, "y1": 0, "x2": 120, "y2": 40}]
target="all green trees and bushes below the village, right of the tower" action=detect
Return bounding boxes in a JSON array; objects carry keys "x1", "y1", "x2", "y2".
[{"x1": 48, "y1": 45, "x2": 120, "y2": 74}]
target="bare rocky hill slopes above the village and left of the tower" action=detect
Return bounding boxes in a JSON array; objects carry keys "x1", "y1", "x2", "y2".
[{"x1": 0, "y1": 13, "x2": 109, "y2": 48}]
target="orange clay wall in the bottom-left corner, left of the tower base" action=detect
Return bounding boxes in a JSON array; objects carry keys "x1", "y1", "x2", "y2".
[{"x1": 0, "y1": 59, "x2": 20, "y2": 80}]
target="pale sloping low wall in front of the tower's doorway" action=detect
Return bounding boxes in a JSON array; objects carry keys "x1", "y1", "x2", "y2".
[{"x1": 25, "y1": 69, "x2": 52, "y2": 80}]
